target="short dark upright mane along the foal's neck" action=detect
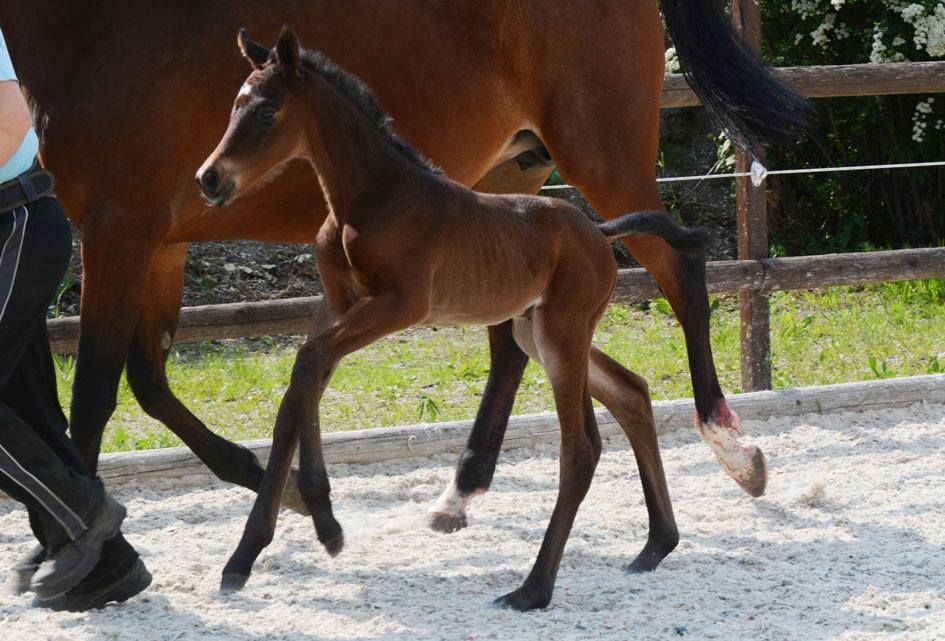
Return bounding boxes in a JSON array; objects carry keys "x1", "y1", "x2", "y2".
[{"x1": 300, "y1": 49, "x2": 442, "y2": 174}]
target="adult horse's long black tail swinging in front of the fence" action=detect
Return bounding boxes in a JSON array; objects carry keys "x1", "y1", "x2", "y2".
[{"x1": 662, "y1": 0, "x2": 811, "y2": 151}]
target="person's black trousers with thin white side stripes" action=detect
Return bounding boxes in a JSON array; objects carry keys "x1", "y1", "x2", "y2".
[{"x1": 0, "y1": 198, "x2": 137, "y2": 576}]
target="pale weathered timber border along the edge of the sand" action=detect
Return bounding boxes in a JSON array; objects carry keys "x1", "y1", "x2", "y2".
[{"x1": 98, "y1": 374, "x2": 945, "y2": 485}]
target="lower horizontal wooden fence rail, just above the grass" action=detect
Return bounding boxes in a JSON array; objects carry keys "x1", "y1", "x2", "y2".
[{"x1": 47, "y1": 248, "x2": 945, "y2": 353}]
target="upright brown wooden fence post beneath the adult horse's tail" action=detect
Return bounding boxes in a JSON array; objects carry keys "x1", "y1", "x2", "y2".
[{"x1": 732, "y1": 0, "x2": 771, "y2": 392}]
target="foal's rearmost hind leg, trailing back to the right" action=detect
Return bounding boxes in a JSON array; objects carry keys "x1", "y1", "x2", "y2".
[{"x1": 590, "y1": 346, "x2": 679, "y2": 572}]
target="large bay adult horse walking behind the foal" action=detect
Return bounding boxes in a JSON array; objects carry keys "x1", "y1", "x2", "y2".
[{"x1": 0, "y1": 0, "x2": 798, "y2": 516}]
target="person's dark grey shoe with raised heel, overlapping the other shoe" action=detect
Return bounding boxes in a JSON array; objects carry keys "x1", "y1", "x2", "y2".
[{"x1": 30, "y1": 494, "x2": 125, "y2": 601}]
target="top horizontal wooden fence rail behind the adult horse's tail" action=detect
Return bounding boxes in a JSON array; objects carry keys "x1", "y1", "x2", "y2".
[{"x1": 662, "y1": 62, "x2": 945, "y2": 109}]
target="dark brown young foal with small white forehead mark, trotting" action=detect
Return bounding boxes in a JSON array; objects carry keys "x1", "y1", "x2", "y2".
[{"x1": 197, "y1": 29, "x2": 706, "y2": 610}]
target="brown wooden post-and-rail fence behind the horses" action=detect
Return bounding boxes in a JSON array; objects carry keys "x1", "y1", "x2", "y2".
[{"x1": 49, "y1": 0, "x2": 945, "y2": 392}]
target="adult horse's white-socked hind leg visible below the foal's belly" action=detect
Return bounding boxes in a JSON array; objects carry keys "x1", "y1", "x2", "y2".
[{"x1": 430, "y1": 321, "x2": 528, "y2": 532}]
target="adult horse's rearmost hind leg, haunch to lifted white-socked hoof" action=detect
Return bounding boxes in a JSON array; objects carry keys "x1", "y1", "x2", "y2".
[{"x1": 533, "y1": 15, "x2": 767, "y2": 496}]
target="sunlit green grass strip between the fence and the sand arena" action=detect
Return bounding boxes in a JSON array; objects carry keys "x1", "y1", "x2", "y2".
[{"x1": 58, "y1": 281, "x2": 945, "y2": 451}]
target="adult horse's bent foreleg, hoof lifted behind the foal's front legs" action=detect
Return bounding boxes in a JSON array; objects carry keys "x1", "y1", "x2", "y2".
[{"x1": 127, "y1": 243, "x2": 306, "y2": 514}]
